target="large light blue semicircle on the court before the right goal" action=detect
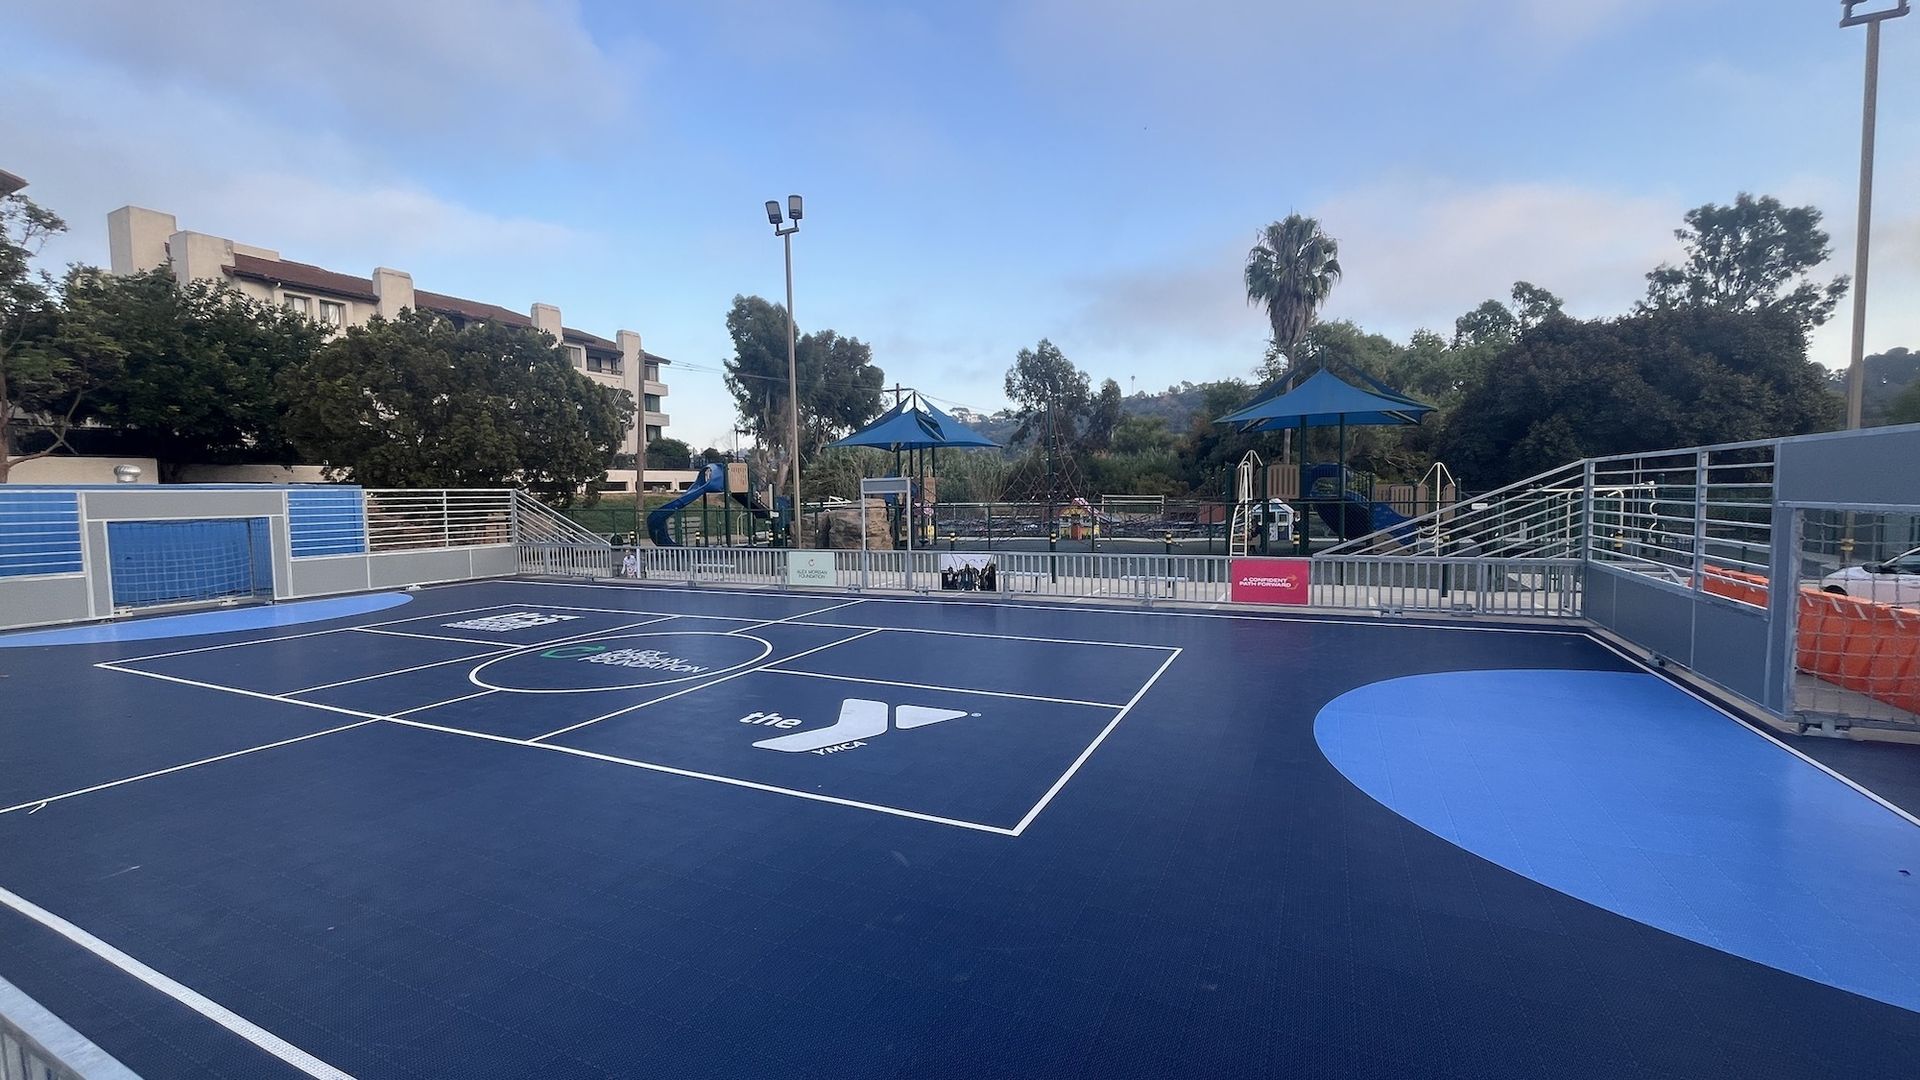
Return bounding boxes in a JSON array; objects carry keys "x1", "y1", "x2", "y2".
[{"x1": 1313, "y1": 671, "x2": 1920, "y2": 1011}]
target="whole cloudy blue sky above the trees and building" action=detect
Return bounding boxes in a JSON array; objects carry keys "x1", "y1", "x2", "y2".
[{"x1": 0, "y1": 0, "x2": 1920, "y2": 446}]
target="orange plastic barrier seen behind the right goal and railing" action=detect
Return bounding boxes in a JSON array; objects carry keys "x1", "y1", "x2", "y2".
[{"x1": 1701, "y1": 567, "x2": 1920, "y2": 713}]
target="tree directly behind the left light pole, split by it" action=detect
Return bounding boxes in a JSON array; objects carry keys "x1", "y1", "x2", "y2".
[{"x1": 726, "y1": 296, "x2": 887, "y2": 475}]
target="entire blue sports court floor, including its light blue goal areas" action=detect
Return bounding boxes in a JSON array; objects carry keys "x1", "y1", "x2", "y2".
[{"x1": 0, "y1": 580, "x2": 1920, "y2": 1078}]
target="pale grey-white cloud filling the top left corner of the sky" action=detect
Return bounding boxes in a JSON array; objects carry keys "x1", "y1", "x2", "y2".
[{"x1": 8, "y1": 0, "x2": 647, "y2": 144}]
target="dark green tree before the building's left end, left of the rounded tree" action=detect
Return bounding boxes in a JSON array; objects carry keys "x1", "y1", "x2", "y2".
[{"x1": 65, "y1": 269, "x2": 328, "y2": 469}]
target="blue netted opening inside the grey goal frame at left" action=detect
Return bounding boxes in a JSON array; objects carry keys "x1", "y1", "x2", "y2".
[{"x1": 108, "y1": 517, "x2": 273, "y2": 607}]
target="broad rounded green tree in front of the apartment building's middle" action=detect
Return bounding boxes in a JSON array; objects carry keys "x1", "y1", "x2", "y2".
[{"x1": 280, "y1": 311, "x2": 634, "y2": 505}]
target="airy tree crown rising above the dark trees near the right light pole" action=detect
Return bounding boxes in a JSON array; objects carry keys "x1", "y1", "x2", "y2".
[{"x1": 1640, "y1": 192, "x2": 1847, "y2": 331}]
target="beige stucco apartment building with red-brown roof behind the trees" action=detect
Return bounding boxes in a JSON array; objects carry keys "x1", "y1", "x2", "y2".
[{"x1": 108, "y1": 206, "x2": 672, "y2": 490}]
